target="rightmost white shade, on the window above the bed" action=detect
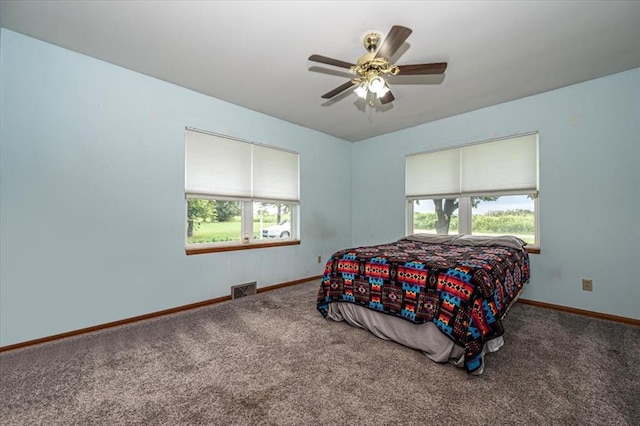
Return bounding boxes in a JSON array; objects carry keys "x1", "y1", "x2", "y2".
[{"x1": 461, "y1": 134, "x2": 538, "y2": 195}]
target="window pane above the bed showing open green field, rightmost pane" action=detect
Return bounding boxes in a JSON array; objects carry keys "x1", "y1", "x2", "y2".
[{"x1": 471, "y1": 195, "x2": 535, "y2": 244}]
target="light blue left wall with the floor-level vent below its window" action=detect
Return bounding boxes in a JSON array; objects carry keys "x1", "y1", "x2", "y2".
[{"x1": 0, "y1": 29, "x2": 352, "y2": 346}]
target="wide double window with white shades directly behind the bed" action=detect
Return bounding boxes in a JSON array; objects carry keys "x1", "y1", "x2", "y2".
[{"x1": 405, "y1": 134, "x2": 540, "y2": 248}]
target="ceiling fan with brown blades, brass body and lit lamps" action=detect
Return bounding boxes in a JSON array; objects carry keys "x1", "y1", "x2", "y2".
[{"x1": 309, "y1": 25, "x2": 447, "y2": 106}]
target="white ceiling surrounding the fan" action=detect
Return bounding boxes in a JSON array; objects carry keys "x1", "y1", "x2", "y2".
[{"x1": 0, "y1": 0, "x2": 640, "y2": 141}]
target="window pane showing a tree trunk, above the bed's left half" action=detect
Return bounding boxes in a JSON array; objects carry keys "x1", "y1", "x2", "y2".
[{"x1": 413, "y1": 198, "x2": 458, "y2": 235}]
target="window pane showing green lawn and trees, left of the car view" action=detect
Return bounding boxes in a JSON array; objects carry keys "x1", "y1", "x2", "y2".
[{"x1": 187, "y1": 198, "x2": 242, "y2": 244}]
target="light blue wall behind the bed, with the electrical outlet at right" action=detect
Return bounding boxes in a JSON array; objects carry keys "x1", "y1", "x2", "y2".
[{"x1": 352, "y1": 69, "x2": 640, "y2": 319}]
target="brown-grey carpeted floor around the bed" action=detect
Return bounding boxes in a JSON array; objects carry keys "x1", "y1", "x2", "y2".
[{"x1": 0, "y1": 281, "x2": 640, "y2": 425}]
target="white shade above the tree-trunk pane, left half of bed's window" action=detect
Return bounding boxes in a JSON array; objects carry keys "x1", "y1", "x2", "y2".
[{"x1": 405, "y1": 148, "x2": 460, "y2": 197}]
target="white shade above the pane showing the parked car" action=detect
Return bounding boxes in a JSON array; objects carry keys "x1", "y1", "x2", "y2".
[{"x1": 253, "y1": 145, "x2": 300, "y2": 201}]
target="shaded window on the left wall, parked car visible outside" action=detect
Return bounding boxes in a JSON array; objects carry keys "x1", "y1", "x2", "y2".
[{"x1": 185, "y1": 129, "x2": 299, "y2": 251}]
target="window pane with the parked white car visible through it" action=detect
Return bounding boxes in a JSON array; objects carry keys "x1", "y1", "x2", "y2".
[{"x1": 253, "y1": 202, "x2": 293, "y2": 239}]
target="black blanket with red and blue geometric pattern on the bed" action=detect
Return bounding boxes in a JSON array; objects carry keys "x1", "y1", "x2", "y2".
[{"x1": 317, "y1": 239, "x2": 530, "y2": 372}]
